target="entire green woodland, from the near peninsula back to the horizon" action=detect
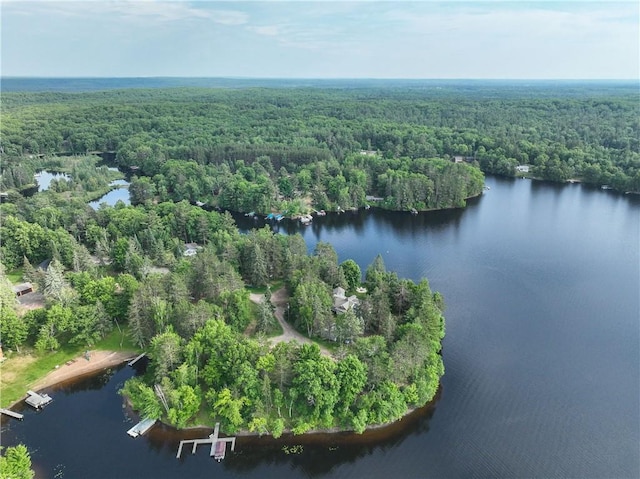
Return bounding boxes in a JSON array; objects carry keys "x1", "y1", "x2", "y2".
[{"x1": 0, "y1": 84, "x2": 640, "y2": 437}]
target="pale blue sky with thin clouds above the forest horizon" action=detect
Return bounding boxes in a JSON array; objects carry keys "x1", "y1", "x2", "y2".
[{"x1": 0, "y1": 0, "x2": 640, "y2": 79}]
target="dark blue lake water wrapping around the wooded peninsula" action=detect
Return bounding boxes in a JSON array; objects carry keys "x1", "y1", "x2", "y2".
[{"x1": 2, "y1": 177, "x2": 640, "y2": 479}]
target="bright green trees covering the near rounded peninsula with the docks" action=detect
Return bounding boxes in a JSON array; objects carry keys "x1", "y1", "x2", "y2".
[{"x1": 0, "y1": 191, "x2": 444, "y2": 436}]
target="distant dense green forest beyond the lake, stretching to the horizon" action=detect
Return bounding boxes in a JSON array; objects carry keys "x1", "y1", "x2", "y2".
[{"x1": 0, "y1": 83, "x2": 640, "y2": 207}]
